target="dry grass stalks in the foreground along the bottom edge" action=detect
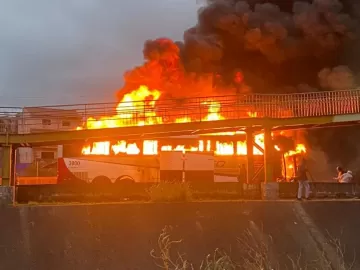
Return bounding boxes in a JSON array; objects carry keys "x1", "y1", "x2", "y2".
[{"x1": 150, "y1": 227, "x2": 355, "y2": 270}]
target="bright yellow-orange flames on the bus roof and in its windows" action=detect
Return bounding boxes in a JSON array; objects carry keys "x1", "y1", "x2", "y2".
[{"x1": 77, "y1": 86, "x2": 306, "y2": 179}]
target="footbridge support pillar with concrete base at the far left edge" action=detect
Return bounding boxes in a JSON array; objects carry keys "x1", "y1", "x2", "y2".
[{"x1": 0, "y1": 145, "x2": 15, "y2": 205}]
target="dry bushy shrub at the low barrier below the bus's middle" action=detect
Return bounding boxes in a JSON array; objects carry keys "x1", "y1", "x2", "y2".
[{"x1": 149, "y1": 182, "x2": 192, "y2": 202}]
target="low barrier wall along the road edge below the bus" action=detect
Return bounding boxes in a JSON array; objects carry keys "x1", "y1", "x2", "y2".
[{"x1": 15, "y1": 181, "x2": 360, "y2": 203}]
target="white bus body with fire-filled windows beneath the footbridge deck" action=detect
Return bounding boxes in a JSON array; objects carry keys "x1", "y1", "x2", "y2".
[{"x1": 58, "y1": 132, "x2": 301, "y2": 183}]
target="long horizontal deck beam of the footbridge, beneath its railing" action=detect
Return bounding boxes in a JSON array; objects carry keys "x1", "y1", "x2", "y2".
[{"x1": 0, "y1": 114, "x2": 342, "y2": 146}]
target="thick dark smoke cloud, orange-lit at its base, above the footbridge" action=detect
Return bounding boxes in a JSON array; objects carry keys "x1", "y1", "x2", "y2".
[{"x1": 118, "y1": 0, "x2": 360, "y2": 167}]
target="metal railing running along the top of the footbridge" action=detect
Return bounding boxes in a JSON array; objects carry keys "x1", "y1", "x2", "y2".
[{"x1": 0, "y1": 89, "x2": 360, "y2": 133}]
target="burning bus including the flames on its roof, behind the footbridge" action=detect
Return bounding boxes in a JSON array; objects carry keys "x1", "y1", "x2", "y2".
[{"x1": 54, "y1": 86, "x2": 305, "y2": 183}]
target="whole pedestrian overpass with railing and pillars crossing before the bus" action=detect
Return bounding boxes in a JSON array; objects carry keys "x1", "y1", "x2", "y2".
[{"x1": 0, "y1": 89, "x2": 360, "y2": 184}]
